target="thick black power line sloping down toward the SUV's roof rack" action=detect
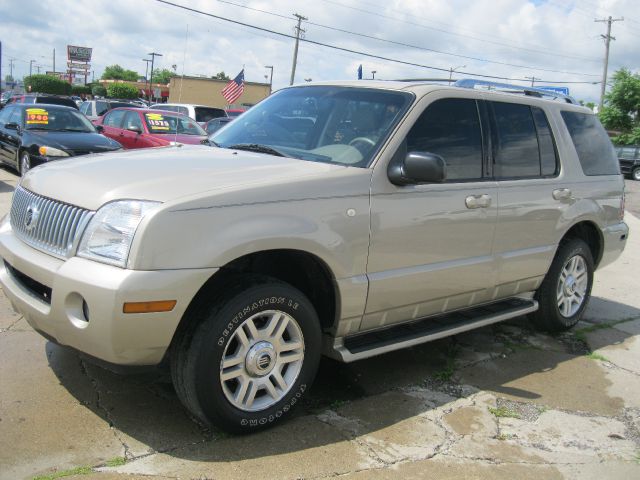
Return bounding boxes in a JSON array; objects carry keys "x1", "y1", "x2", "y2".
[{"x1": 155, "y1": 0, "x2": 595, "y2": 83}]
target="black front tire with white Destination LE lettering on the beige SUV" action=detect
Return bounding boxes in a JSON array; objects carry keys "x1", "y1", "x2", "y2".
[{"x1": 171, "y1": 275, "x2": 321, "y2": 433}]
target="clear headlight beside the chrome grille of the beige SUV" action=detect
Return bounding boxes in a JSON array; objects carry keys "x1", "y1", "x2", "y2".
[{"x1": 78, "y1": 200, "x2": 159, "y2": 268}]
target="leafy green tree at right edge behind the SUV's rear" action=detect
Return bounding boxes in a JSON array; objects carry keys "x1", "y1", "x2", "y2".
[{"x1": 599, "y1": 68, "x2": 640, "y2": 145}]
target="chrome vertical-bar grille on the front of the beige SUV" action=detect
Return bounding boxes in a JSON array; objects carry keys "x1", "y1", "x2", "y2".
[{"x1": 11, "y1": 187, "x2": 93, "y2": 258}]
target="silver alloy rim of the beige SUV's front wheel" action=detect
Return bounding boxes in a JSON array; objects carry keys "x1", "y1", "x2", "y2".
[{"x1": 220, "y1": 310, "x2": 304, "y2": 412}]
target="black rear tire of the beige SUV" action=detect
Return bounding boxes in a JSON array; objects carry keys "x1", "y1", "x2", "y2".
[{"x1": 529, "y1": 238, "x2": 594, "y2": 332}]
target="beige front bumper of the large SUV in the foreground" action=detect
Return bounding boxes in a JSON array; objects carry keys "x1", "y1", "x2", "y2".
[{"x1": 0, "y1": 224, "x2": 218, "y2": 365}]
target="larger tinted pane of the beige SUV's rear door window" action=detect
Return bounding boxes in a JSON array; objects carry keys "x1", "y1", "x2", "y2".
[{"x1": 491, "y1": 102, "x2": 540, "y2": 178}]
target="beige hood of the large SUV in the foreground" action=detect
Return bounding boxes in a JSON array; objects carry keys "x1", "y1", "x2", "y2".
[{"x1": 22, "y1": 145, "x2": 370, "y2": 210}]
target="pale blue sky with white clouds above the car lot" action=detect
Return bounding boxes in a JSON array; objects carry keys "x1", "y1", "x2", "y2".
[{"x1": 0, "y1": 0, "x2": 640, "y2": 103}]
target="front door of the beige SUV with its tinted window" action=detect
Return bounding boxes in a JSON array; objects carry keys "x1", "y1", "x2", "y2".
[{"x1": 361, "y1": 96, "x2": 498, "y2": 330}]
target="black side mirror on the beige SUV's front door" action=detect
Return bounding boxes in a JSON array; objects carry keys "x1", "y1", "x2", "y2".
[{"x1": 388, "y1": 152, "x2": 447, "y2": 185}]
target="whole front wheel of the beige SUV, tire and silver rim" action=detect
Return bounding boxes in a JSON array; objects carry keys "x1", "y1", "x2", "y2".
[{"x1": 171, "y1": 276, "x2": 321, "y2": 433}]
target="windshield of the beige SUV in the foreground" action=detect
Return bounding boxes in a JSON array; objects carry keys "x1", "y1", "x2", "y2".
[{"x1": 211, "y1": 86, "x2": 413, "y2": 167}]
